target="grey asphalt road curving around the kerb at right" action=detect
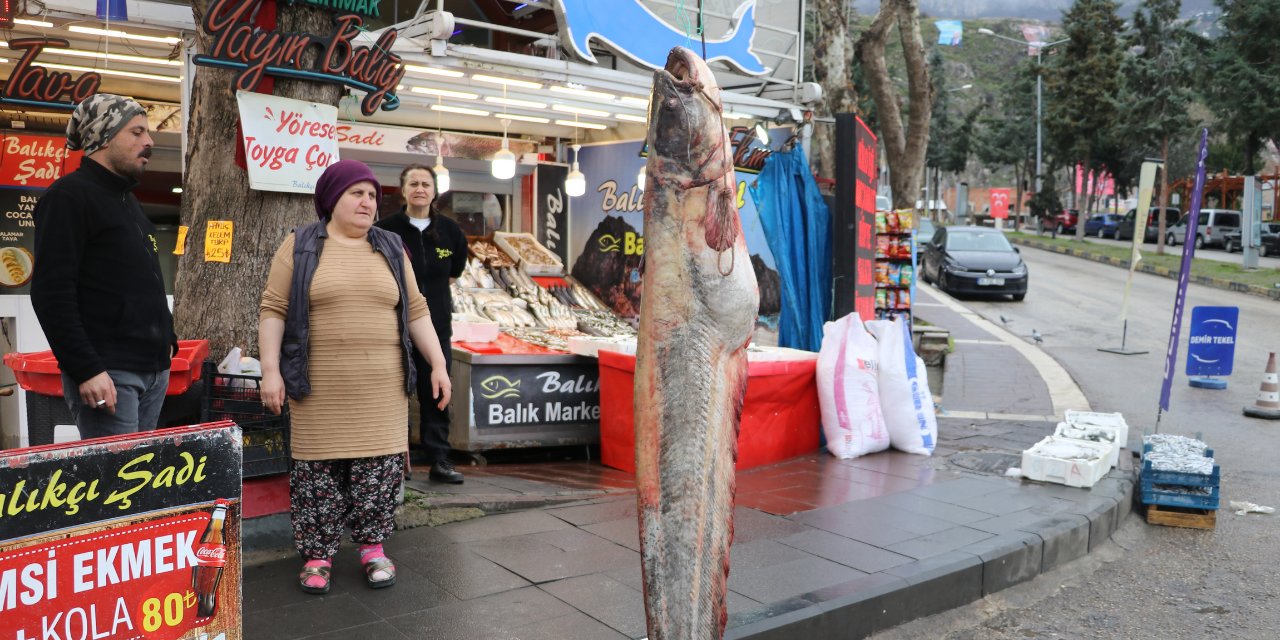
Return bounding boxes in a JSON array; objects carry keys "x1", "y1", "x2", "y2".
[{"x1": 876, "y1": 247, "x2": 1280, "y2": 640}]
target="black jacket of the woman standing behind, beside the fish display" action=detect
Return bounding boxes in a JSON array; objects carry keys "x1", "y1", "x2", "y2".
[{"x1": 376, "y1": 209, "x2": 467, "y2": 340}]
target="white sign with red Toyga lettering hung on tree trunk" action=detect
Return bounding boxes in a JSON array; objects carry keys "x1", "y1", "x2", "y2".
[{"x1": 236, "y1": 91, "x2": 338, "y2": 193}]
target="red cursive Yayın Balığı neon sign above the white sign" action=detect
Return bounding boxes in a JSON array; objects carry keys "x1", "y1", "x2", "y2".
[{"x1": 192, "y1": 0, "x2": 404, "y2": 115}]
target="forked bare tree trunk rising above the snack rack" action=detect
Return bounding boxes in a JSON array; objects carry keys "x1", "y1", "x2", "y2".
[{"x1": 856, "y1": 0, "x2": 933, "y2": 209}]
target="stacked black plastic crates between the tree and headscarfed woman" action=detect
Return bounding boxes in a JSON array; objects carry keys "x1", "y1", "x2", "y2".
[{"x1": 201, "y1": 361, "x2": 289, "y2": 477}]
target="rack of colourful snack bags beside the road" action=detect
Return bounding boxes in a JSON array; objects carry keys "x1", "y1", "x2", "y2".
[{"x1": 876, "y1": 209, "x2": 918, "y2": 323}]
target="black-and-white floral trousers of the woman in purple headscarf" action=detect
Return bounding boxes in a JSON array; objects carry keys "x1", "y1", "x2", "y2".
[{"x1": 289, "y1": 453, "x2": 404, "y2": 559}]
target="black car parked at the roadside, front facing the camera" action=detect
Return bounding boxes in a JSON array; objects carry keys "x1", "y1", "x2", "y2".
[{"x1": 920, "y1": 227, "x2": 1029, "y2": 300}]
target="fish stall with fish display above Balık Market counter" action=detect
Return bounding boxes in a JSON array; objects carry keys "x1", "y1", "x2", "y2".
[{"x1": 449, "y1": 234, "x2": 635, "y2": 452}]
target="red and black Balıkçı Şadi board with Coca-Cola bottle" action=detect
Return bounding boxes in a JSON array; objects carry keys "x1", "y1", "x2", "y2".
[{"x1": 0, "y1": 422, "x2": 242, "y2": 640}]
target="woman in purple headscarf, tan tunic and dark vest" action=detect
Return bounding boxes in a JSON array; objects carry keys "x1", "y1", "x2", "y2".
[{"x1": 259, "y1": 160, "x2": 452, "y2": 594}]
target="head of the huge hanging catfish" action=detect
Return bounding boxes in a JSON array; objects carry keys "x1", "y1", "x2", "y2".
[{"x1": 646, "y1": 47, "x2": 730, "y2": 184}]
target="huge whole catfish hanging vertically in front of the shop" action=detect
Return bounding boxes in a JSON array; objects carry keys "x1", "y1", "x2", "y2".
[{"x1": 635, "y1": 47, "x2": 760, "y2": 640}]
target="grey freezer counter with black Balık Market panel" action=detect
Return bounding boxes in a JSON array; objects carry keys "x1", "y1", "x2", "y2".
[{"x1": 449, "y1": 346, "x2": 600, "y2": 452}]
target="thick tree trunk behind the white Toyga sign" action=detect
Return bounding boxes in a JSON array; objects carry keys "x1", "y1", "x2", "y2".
[{"x1": 173, "y1": 0, "x2": 342, "y2": 360}]
